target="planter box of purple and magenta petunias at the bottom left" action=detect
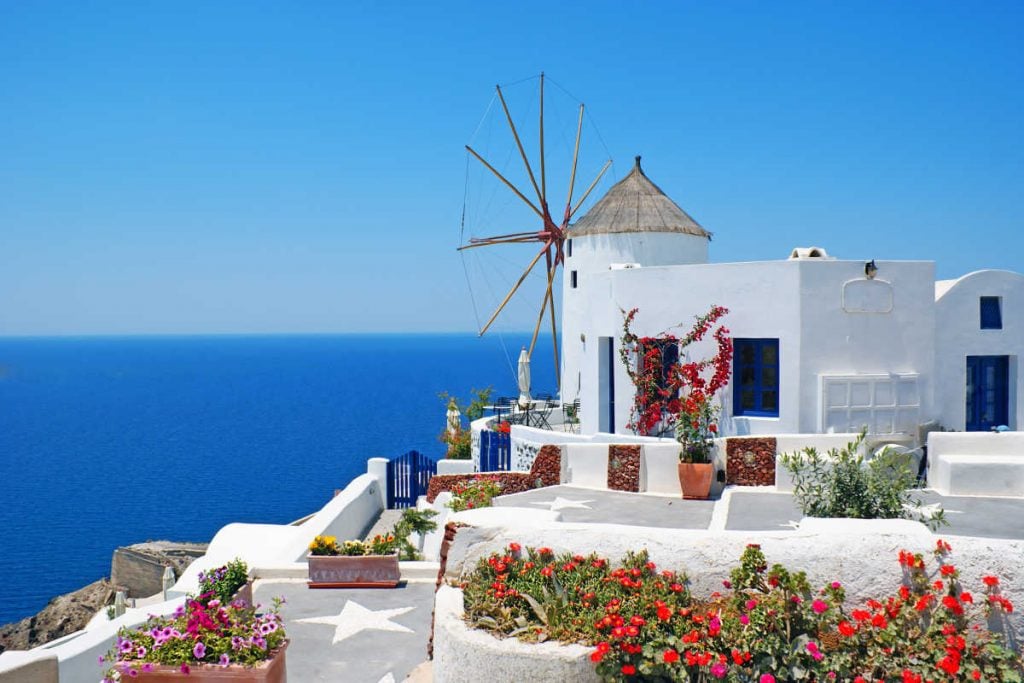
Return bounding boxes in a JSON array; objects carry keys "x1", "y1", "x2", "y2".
[{"x1": 102, "y1": 594, "x2": 288, "y2": 683}]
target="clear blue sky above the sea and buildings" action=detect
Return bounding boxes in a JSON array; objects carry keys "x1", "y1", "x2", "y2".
[{"x1": 0, "y1": 1, "x2": 1024, "y2": 334}]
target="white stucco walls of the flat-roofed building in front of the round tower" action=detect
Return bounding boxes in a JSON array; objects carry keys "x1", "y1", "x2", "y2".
[{"x1": 563, "y1": 259, "x2": 935, "y2": 444}]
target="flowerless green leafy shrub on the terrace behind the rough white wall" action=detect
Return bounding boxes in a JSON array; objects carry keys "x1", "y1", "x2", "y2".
[{"x1": 781, "y1": 431, "x2": 947, "y2": 529}]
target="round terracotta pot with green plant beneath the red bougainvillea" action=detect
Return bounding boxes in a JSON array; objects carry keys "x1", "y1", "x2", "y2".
[{"x1": 676, "y1": 391, "x2": 719, "y2": 500}]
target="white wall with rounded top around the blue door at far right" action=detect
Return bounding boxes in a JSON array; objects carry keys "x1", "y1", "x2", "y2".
[{"x1": 935, "y1": 270, "x2": 1024, "y2": 430}]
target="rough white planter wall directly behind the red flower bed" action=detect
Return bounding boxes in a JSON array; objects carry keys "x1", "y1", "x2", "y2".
[{"x1": 445, "y1": 515, "x2": 1024, "y2": 643}]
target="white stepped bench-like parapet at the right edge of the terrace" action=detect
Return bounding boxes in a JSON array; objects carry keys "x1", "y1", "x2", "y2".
[{"x1": 928, "y1": 432, "x2": 1024, "y2": 497}]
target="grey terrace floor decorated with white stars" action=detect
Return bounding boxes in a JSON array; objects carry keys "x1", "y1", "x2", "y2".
[{"x1": 266, "y1": 485, "x2": 1024, "y2": 683}]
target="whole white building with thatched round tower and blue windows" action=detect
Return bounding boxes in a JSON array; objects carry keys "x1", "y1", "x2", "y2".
[{"x1": 561, "y1": 158, "x2": 1024, "y2": 439}]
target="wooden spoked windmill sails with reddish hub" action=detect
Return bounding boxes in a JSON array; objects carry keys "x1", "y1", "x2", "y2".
[{"x1": 459, "y1": 73, "x2": 611, "y2": 389}]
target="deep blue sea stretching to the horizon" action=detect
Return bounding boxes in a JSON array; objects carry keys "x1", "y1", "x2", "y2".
[{"x1": 0, "y1": 334, "x2": 555, "y2": 624}]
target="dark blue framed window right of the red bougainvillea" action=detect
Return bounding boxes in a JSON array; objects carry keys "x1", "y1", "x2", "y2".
[{"x1": 732, "y1": 339, "x2": 778, "y2": 418}]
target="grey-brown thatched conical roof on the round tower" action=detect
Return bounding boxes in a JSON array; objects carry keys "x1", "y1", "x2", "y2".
[{"x1": 569, "y1": 157, "x2": 711, "y2": 240}]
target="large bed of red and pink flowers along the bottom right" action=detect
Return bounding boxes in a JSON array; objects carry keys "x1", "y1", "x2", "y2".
[{"x1": 460, "y1": 541, "x2": 1022, "y2": 683}]
